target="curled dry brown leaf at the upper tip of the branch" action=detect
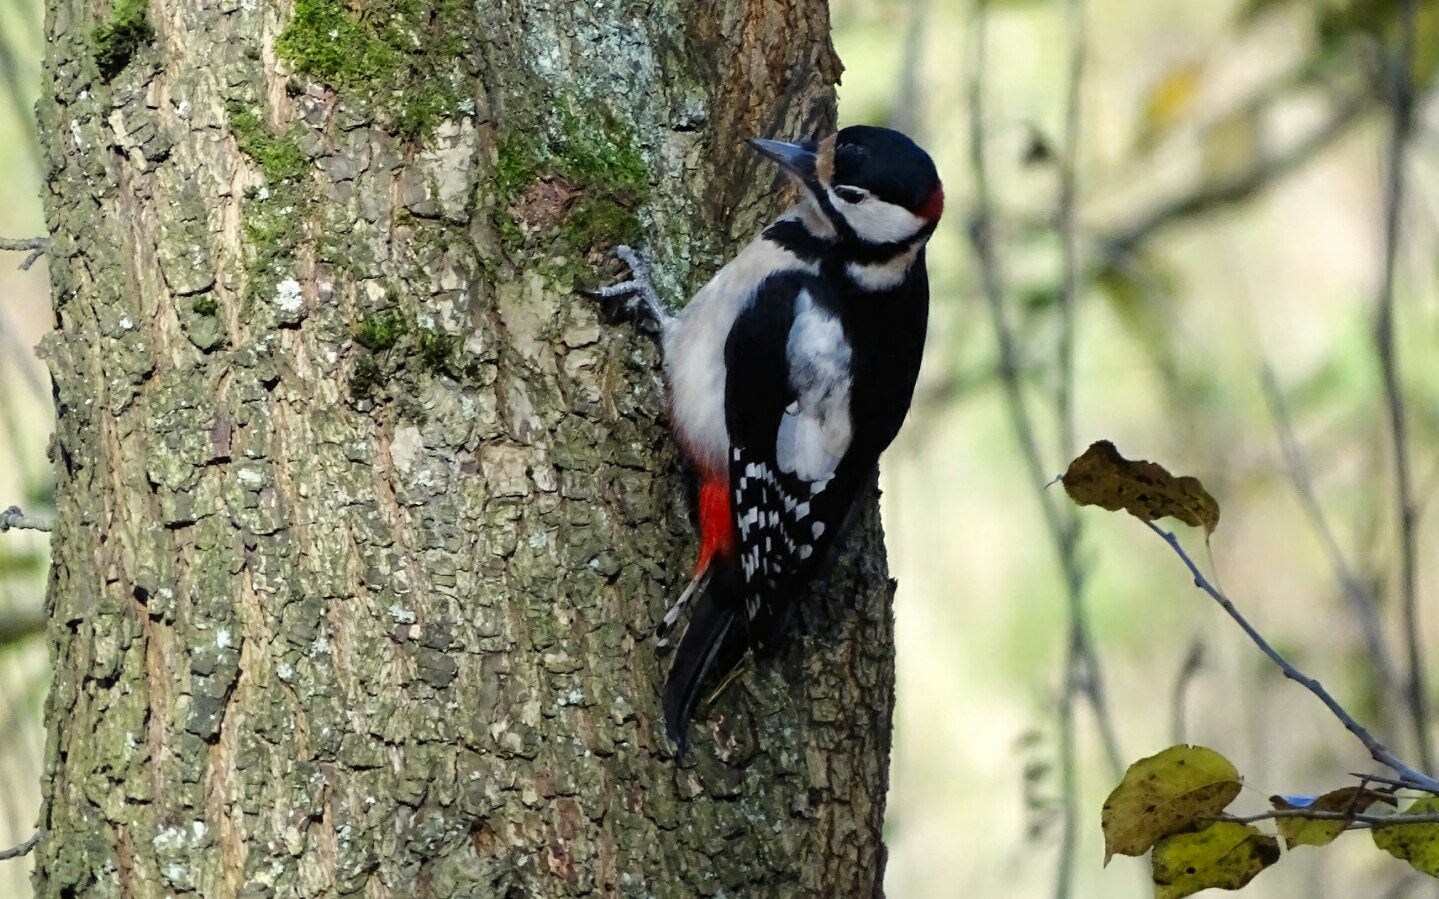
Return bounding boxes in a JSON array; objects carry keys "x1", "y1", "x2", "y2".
[{"x1": 1061, "y1": 440, "x2": 1219, "y2": 534}]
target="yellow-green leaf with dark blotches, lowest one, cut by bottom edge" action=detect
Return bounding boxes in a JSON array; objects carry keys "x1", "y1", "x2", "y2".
[{"x1": 1150, "y1": 821, "x2": 1279, "y2": 899}]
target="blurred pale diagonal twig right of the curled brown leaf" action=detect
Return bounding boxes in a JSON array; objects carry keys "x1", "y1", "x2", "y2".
[{"x1": 1259, "y1": 364, "x2": 1404, "y2": 699}]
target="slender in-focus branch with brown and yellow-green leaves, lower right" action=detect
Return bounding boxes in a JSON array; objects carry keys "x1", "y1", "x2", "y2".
[{"x1": 1061, "y1": 440, "x2": 1439, "y2": 899}]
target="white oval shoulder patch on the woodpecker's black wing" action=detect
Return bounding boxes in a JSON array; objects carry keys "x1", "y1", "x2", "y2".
[{"x1": 774, "y1": 291, "x2": 852, "y2": 483}]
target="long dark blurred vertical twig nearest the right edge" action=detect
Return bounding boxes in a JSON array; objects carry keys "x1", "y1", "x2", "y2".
[{"x1": 1374, "y1": 0, "x2": 1432, "y2": 768}]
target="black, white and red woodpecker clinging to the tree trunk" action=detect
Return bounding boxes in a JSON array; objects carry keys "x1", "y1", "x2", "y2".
[{"x1": 602, "y1": 125, "x2": 944, "y2": 754}]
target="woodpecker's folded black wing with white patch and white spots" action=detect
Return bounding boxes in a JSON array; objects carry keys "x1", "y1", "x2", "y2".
[{"x1": 725, "y1": 273, "x2": 873, "y2": 650}]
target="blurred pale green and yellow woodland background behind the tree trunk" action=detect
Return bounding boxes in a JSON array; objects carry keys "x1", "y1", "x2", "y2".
[{"x1": 0, "y1": 0, "x2": 1439, "y2": 899}]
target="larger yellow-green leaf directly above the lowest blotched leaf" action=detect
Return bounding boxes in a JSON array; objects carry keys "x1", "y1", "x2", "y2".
[{"x1": 1099, "y1": 747, "x2": 1240, "y2": 863}]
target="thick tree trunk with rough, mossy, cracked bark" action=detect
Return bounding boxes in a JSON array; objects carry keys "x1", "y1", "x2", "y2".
[{"x1": 35, "y1": 0, "x2": 894, "y2": 899}]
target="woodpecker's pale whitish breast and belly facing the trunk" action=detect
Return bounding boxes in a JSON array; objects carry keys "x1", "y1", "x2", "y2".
[{"x1": 665, "y1": 237, "x2": 817, "y2": 478}]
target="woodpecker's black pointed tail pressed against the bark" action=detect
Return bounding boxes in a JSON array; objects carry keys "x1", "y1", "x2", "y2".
[{"x1": 665, "y1": 563, "x2": 745, "y2": 757}]
